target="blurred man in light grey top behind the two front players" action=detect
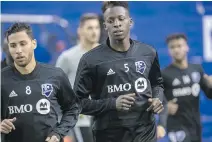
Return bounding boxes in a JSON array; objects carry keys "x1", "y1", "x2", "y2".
[{"x1": 56, "y1": 14, "x2": 100, "y2": 85}]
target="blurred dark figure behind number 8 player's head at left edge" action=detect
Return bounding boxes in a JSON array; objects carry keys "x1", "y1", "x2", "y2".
[{"x1": 1, "y1": 39, "x2": 13, "y2": 69}]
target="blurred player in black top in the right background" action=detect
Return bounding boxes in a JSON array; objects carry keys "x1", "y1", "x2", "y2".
[{"x1": 162, "y1": 34, "x2": 212, "y2": 142}]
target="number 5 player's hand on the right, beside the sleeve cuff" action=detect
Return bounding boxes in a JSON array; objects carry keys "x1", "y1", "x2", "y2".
[{"x1": 147, "y1": 98, "x2": 164, "y2": 114}]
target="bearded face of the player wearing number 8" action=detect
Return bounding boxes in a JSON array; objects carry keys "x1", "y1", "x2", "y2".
[{"x1": 8, "y1": 31, "x2": 36, "y2": 67}]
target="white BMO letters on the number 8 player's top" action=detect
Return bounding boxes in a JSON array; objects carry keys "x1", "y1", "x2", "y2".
[{"x1": 8, "y1": 104, "x2": 33, "y2": 114}]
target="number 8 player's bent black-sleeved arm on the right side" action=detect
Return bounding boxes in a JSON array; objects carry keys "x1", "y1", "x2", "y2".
[{"x1": 49, "y1": 70, "x2": 81, "y2": 138}]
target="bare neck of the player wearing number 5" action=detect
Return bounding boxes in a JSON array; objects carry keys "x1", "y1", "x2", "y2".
[{"x1": 110, "y1": 37, "x2": 130, "y2": 52}]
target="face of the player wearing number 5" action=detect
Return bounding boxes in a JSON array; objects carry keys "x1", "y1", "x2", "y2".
[{"x1": 104, "y1": 6, "x2": 132, "y2": 40}]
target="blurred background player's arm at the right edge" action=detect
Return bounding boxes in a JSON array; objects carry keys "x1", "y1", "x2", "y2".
[{"x1": 200, "y1": 67, "x2": 212, "y2": 99}]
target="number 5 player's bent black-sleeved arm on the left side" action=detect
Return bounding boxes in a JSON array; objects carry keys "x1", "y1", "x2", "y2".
[{"x1": 74, "y1": 57, "x2": 116, "y2": 115}]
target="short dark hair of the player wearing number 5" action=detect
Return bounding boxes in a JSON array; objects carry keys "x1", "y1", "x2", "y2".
[{"x1": 102, "y1": 1, "x2": 129, "y2": 13}]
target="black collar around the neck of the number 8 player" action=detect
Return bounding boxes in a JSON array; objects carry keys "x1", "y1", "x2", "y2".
[{"x1": 13, "y1": 62, "x2": 40, "y2": 80}]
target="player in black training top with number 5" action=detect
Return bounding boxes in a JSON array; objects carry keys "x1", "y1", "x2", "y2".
[{"x1": 74, "y1": 1, "x2": 163, "y2": 142}]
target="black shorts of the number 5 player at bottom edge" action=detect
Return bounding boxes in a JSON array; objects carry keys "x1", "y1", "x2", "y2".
[{"x1": 94, "y1": 123, "x2": 157, "y2": 142}]
